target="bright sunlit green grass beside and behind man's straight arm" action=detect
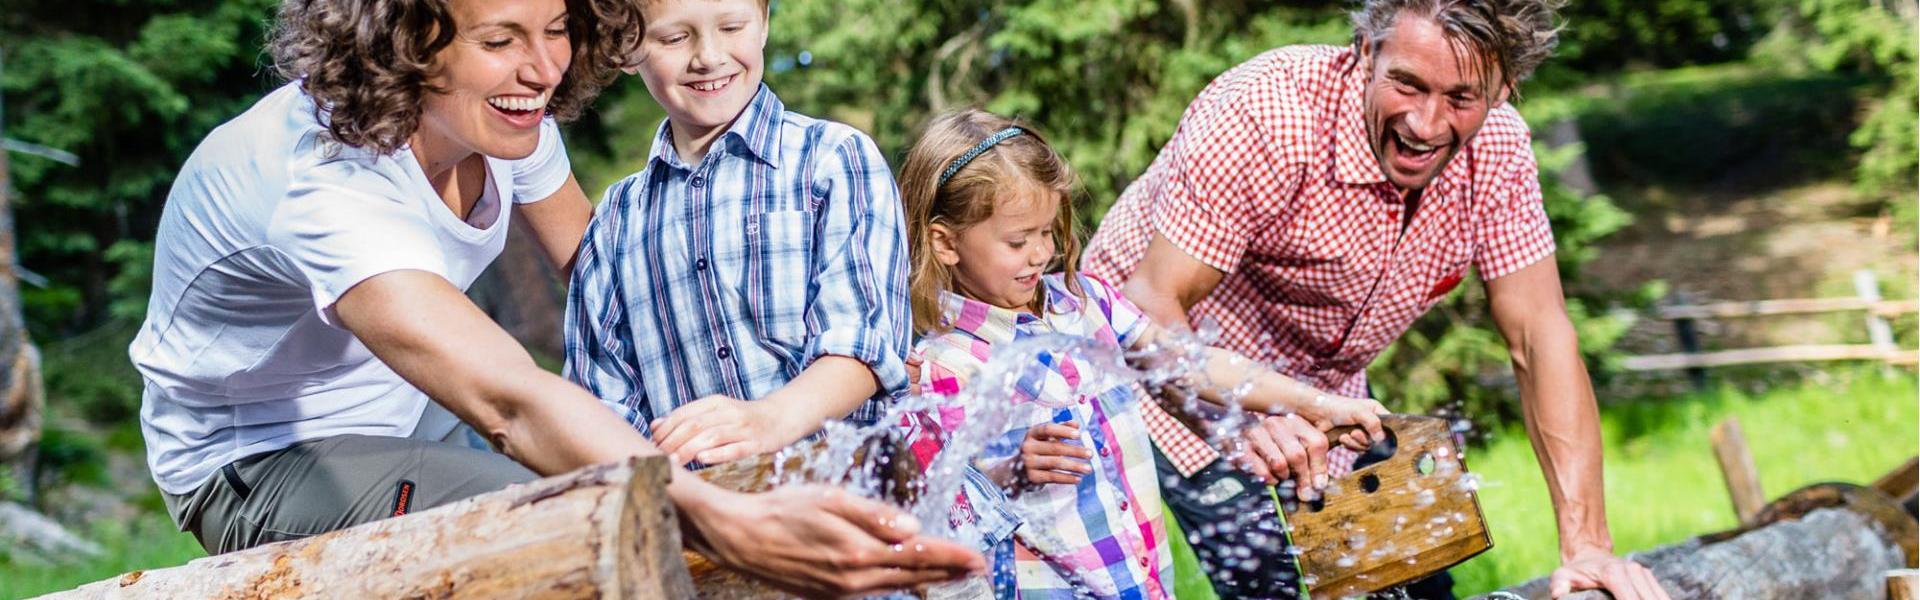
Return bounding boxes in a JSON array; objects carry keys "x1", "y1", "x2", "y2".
[{"x1": 1453, "y1": 369, "x2": 1920, "y2": 594}]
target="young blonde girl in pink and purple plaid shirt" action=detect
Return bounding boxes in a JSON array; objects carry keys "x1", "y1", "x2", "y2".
[{"x1": 900, "y1": 110, "x2": 1386, "y2": 598}]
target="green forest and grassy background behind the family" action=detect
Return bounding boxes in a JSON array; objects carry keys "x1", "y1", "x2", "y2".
[{"x1": 0, "y1": 0, "x2": 1920, "y2": 598}]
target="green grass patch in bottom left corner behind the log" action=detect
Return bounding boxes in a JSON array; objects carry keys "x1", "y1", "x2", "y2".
[{"x1": 0, "y1": 513, "x2": 205, "y2": 598}]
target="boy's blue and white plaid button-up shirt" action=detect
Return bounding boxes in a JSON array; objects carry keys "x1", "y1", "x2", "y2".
[{"x1": 564, "y1": 85, "x2": 910, "y2": 435}]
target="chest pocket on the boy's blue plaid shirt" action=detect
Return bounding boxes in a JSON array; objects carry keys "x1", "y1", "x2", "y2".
[{"x1": 741, "y1": 210, "x2": 814, "y2": 350}]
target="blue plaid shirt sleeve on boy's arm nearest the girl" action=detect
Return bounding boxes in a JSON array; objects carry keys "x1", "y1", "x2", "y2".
[{"x1": 804, "y1": 133, "x2": 910, "y2": 405}]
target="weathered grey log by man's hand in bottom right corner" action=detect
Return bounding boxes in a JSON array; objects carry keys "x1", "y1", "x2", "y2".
[{"x1": 1482, "y1": 485, "x2": 1914, "y2": 600}]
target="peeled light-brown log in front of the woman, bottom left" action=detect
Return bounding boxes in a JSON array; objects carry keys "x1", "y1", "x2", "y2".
[{"x1": 46, "y1": 456, "x2": 693, "y2": 598}]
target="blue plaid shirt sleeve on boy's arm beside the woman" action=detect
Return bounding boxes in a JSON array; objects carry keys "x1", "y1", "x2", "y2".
[{"x1": 563, "y1": 181, "x2": 651, "y2": 435}]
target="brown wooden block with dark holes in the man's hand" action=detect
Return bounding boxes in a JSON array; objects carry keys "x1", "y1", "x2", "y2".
[{"x1": 1286, "y1": 415, "x2": 1494, "y2": 598}]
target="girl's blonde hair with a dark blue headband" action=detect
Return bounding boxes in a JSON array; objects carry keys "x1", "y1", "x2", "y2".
[{"x1": 900, "y1": 108, "x2": 1085, "y2": 335}]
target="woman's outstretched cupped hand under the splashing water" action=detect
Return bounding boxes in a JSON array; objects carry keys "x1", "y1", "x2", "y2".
[{"x1": 680, "y1": 484, "x2": 987, "y2": 598}]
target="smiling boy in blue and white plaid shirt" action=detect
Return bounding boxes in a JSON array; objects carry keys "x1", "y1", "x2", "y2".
[{"x1": 566, "y1": 0, "x2": 908, "y2": 463}]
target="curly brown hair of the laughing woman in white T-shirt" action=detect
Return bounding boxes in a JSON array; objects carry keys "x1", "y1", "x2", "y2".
[{"x1": 269, "y1": 0, "x2": 643, "y2": 154}]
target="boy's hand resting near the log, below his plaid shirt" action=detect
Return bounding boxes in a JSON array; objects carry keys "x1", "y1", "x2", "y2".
[{"x1": 651, "y1": 394, "x2": 802, "y2": 465}]
